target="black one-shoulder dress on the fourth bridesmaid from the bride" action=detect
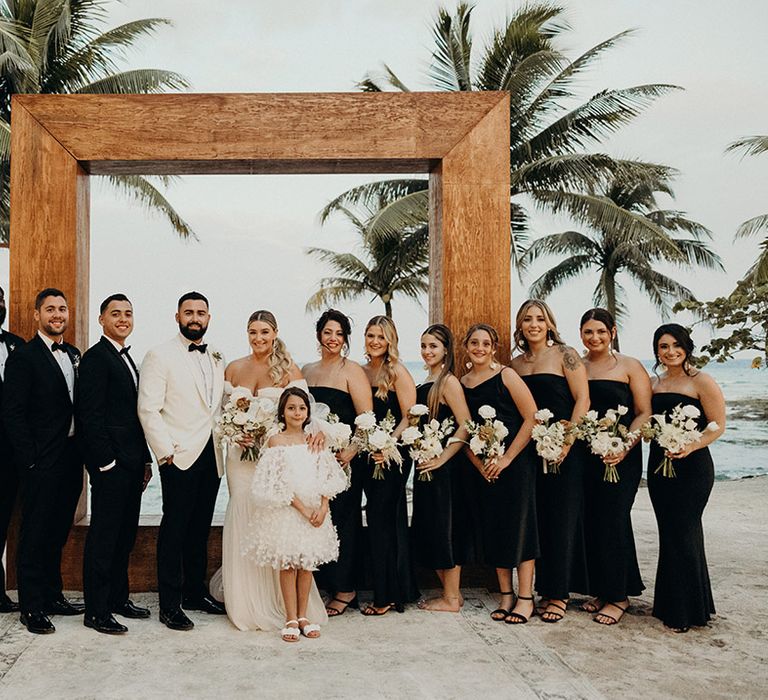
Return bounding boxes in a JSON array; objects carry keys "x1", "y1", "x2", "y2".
[{"x1": 464, "y1": 372, "x2": 539, "y2": 569}]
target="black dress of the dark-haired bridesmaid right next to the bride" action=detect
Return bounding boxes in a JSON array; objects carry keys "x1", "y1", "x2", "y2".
[{"x1": 309, "y1": 386, "x2": 366, "y2": 597}]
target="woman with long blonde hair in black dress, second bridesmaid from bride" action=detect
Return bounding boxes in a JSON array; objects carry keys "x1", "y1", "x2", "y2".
[{"x1": 362, "y1": 316, "x2": 418, "y2": 616}]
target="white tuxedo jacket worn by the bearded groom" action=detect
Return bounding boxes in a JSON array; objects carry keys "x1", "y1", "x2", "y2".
[{"x1": 139, "y1": 334, "x2": 224, "y2": 476}]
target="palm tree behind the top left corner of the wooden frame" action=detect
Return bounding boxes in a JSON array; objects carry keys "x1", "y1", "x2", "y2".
[{"x1": 0, "y1": 0, "x2": 194, "y2": 241}]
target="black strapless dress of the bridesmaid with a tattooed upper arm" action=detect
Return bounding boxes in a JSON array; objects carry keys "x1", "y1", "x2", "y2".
[{"x1": 522, "y1": 373, "x2": 589, "y2": 600}]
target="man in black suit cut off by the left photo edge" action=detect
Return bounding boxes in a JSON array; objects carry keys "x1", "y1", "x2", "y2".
[{"x1": 0, "y1": 287, "x2": 24, "y2": 613}]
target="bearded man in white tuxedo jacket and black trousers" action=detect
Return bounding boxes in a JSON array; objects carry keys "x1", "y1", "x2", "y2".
[{"x1": 139, "y1": 292, "x2": 225, "y2": 630}]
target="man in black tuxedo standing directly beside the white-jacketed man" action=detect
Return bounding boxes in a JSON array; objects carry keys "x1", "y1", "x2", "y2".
[{"x1": 75, "y1": 294, "x2": 152, "y2": 634}]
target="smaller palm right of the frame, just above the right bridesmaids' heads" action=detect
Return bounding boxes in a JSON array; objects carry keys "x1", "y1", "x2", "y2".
[{"x1": 525, "y1": 174, "x2": 723, "y2": 340}]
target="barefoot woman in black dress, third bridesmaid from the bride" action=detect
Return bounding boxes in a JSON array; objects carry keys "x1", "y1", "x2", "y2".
[{"x1": 411, "y1": 323, "x2": 469, "y2": 612}]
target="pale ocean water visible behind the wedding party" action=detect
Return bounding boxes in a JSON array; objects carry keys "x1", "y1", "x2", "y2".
[{"x1": 141, "y1": 360, "x2": 768, "y2": 515}]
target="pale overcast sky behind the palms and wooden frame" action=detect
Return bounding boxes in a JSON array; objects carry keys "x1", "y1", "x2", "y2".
[{"x1": 0, "y1": 0, "x2": 768, "y2": 361}]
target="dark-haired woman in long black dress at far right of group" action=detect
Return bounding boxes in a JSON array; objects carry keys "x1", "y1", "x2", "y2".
[{"x1": 648, "y1": 323, "x2": 725, "y2": 632}]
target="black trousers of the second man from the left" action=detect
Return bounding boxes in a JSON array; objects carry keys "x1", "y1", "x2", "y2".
[{"x1": 16, "y1": 438, "x2": 83, "y2": 612}]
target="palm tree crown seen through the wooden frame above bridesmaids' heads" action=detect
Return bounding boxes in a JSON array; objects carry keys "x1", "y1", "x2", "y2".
[{"x1": 306, "y1": 198, "x2": 429, "y2": 318}]
